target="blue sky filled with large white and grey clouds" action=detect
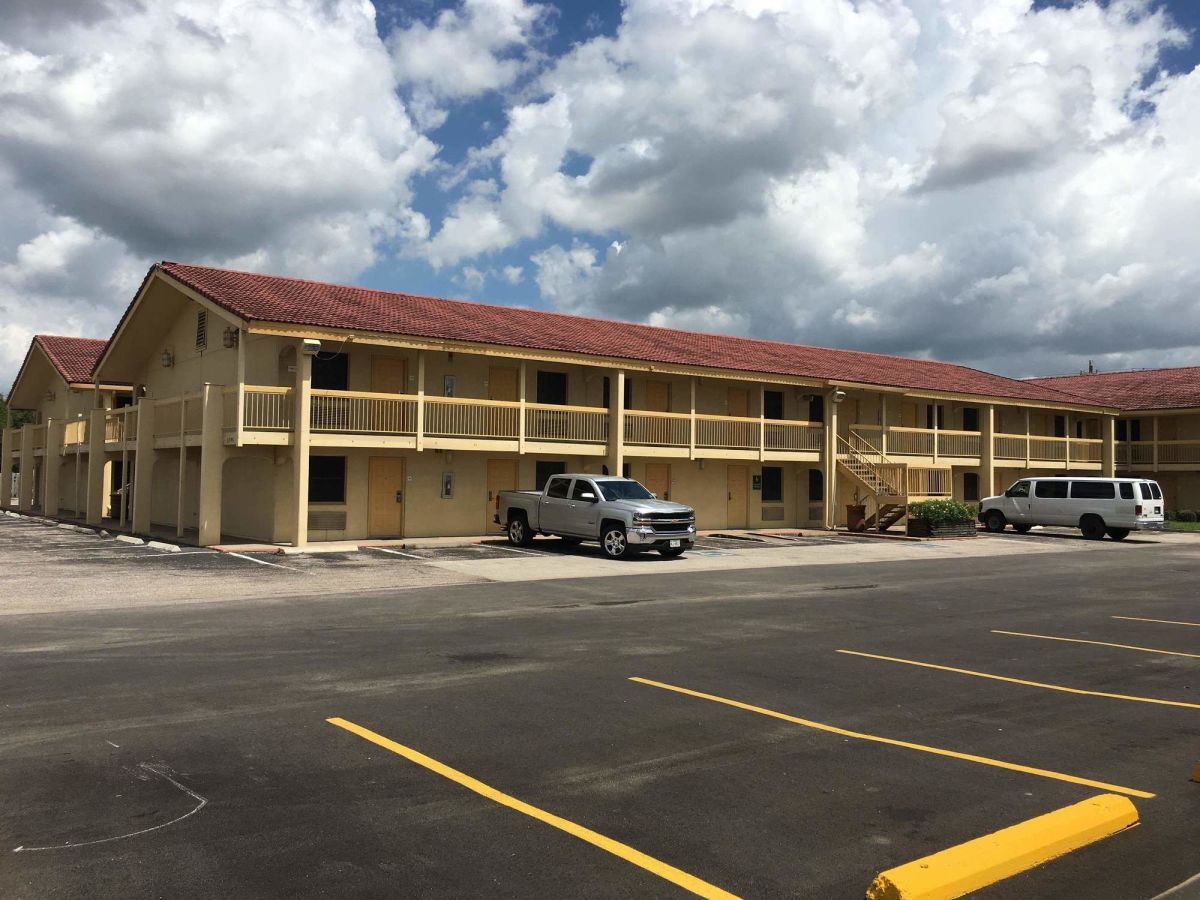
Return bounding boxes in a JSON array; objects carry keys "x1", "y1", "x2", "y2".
[{"x1": 0, "y1": 0, "x2": 1200, "y2": 385}]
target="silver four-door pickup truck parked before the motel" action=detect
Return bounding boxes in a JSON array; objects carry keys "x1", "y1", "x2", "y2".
[{"x1": 496, "y1": 475, "x2": 696, "y2": 559}]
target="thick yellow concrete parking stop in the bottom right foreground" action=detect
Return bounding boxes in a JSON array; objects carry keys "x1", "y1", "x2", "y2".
[{"x1": 866, "y1": 793, "x2": 1138, "y2": 900}]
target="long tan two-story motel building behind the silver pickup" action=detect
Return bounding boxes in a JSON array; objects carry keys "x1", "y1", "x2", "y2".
[{"x1": 7, "y1": 256, "x2": 1171, "y2": 546}]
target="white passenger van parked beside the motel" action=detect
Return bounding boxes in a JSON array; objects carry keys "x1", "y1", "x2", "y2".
[{"x1": 979, "y1": 476, "x2": 1164, "y2": 541}]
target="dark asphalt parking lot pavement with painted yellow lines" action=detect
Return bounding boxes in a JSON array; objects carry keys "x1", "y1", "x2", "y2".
[{"x1": 0, "y1": 520, "x2": 1200, "y2": 898}]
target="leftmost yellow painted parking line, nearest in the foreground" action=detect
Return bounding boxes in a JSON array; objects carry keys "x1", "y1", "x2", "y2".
[{"x1": 325, "y1": 718, "x2": 737, "y2": 900}]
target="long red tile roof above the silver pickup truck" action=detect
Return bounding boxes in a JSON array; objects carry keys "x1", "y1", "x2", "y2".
[{"x1": 151, "y1": 262, "x2": 1099, "y2": 404}]
